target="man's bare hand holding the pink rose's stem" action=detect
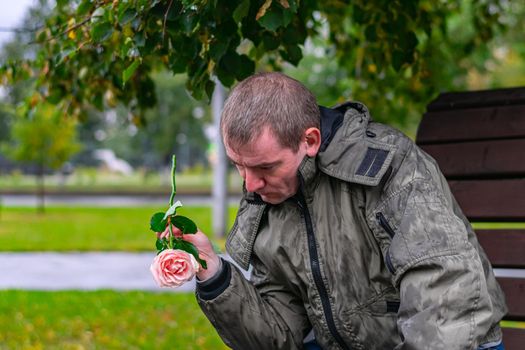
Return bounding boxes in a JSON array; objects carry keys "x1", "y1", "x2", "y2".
[{"x1": 157, "y1": 226, "x2": 221, "y2": 281}]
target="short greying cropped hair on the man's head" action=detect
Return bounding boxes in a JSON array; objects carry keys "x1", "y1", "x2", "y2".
[{"x1": 221, "y1": 72, "x2": 320, "y2": 152}]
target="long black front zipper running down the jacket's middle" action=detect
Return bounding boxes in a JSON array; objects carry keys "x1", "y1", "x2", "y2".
[{"x1": 297, "y1": 192, "x2": 349, "y2": 349}]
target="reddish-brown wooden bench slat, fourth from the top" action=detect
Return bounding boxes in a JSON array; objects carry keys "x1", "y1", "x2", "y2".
[{"x1": 449, "y1": 178, "x2": 525, "y2": 221}]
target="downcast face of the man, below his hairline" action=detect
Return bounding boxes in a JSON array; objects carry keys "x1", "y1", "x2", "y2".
[{"x1": 225, "y1": 128, "x2": 307, "y2": 204}]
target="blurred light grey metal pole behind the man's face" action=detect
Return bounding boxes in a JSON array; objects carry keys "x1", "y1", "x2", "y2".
[{"x1": 211, "y1": 80, "x2": 228, "y2": 237}]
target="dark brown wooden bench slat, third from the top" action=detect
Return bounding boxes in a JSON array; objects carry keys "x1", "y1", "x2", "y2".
[{"x1": 421, "y1": 139, "x2": 525, "y2": 178}]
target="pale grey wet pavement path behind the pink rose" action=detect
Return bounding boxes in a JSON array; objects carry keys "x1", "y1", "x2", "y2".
[{"x1": 0, "y1": 252, "x2": 249, "y2": 292}]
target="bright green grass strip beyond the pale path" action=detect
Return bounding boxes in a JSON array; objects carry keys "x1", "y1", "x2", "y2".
[{"x1": 0, "y1": 206, "x2": 236, "y2": 251}]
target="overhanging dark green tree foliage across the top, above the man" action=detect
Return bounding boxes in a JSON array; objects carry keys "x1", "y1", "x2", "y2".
[{"x1": 2, "y1": 0, "x2": 507, "y2": 124}]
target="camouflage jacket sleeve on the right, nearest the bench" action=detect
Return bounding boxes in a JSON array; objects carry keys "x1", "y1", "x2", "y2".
[{"x1": 379, "y1": 151, "x2": 499, "y2": 349}]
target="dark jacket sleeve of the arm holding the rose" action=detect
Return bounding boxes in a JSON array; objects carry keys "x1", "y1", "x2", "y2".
[{"x1": 196, "y1": 261, "x2": 311, "y2": 350}]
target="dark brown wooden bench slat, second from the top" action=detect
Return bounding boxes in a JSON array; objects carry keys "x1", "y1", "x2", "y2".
[{"x1": 416, "y1": 105, "x2": 525, "y2": 144}]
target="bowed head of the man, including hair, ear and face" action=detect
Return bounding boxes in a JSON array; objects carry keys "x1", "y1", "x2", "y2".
[{"x1": 221, "y1": 73, "x2": 321, "y2": 204}]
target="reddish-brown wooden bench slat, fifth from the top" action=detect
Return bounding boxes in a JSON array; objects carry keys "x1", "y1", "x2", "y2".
[{"x1": 476, "y1": 230, "x2": 525, "y2": 268}]
